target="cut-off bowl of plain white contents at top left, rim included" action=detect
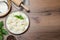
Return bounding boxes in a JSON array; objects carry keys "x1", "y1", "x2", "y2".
[{"x1": 0, "y1": 0, "x2": 12, "y2": 17}]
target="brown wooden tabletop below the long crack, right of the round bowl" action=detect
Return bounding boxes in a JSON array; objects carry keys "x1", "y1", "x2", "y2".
[{"x1": 18, "y1": 12, "x2": 60, "y2": 40}]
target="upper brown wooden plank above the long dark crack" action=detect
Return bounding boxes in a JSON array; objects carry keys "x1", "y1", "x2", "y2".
[{"x1": 30, "y1": 0, "x2": 60, "y2": 12}]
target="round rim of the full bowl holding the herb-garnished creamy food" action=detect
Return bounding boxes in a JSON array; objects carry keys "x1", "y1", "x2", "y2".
[{"x1": 5, "y1": 11, "x2": 30, "y2": 35}]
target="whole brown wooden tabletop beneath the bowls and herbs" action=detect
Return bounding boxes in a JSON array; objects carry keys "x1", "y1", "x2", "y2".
[{"x1": 0, "y1": 0, "x2": 60, "y2": 40}]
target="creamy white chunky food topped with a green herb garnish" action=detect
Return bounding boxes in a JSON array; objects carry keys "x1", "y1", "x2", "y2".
[{"x1": 6, "y1": 11, "x2": 29, "y2": 34}]
